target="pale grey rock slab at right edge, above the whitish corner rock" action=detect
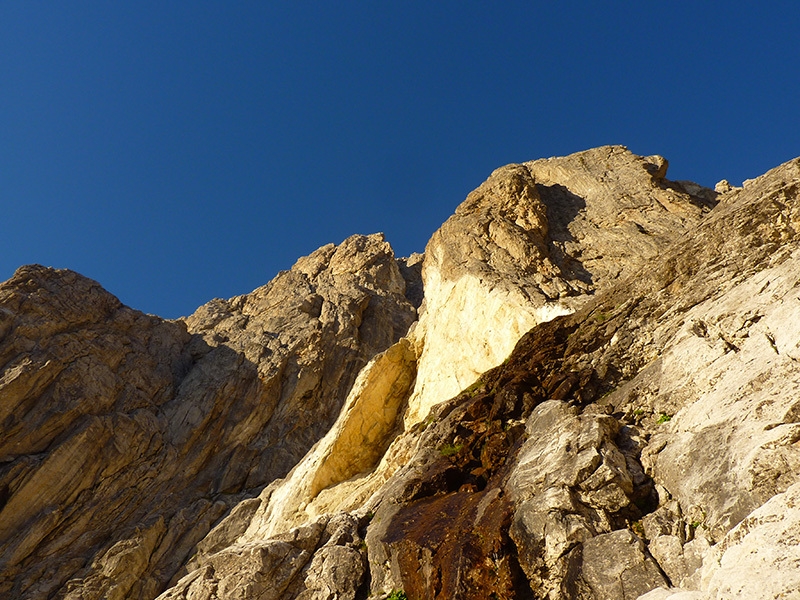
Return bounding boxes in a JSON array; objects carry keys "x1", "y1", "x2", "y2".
[{"x1": 642, "y1": 244, "x2": 800, "y2": 538}]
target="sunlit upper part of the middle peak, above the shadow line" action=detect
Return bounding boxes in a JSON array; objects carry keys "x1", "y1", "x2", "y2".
[{"x1": 185, "y1": 233, "x2": 416, "y2": 376}]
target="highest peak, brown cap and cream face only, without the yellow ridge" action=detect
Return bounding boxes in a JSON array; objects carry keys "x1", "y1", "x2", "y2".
[{"x1": 406, "y1": 146, "x2": 714, "y2": 425}]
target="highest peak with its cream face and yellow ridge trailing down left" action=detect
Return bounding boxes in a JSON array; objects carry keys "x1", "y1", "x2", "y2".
[{"x1": 169, "y1": 148, "x2": 724, "y2": 596}]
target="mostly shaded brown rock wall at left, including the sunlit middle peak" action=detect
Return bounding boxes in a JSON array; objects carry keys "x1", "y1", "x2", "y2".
[{"x1": 0, "y1": 235, "x2": 416, "y2": 599}]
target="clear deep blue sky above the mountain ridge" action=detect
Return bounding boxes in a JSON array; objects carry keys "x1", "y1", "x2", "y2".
[{"x1": 0, "y1": 0, "x2": 800, "y2": 317}]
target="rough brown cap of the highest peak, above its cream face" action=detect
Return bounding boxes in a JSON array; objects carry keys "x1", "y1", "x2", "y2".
[{"x1": 440, "y1": 146, "x2": 716, "y2": 302}]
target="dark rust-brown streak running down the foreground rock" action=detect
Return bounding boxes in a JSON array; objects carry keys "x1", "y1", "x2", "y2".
[{"x1": 376, "y1": 318, "x2": 596, "y2": 599}]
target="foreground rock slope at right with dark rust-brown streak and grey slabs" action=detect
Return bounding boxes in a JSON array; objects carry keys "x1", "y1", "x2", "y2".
[{"x1": 241, "y1": 151, "x2": 800, "y2": 599}]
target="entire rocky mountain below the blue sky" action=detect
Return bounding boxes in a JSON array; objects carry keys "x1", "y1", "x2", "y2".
[{"x1": 0, "y1": 146, "x2": 800, "y2": 600}]
